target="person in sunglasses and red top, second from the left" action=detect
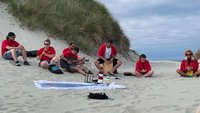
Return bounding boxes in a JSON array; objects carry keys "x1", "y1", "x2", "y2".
[{"x1": 37, "y1": 39, "x2": 56, "y2": 69}]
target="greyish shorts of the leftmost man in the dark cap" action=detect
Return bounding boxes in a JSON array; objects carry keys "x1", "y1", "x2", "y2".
[{"x1": 3, "y1": 49, "x2": 22, "y2": 60}]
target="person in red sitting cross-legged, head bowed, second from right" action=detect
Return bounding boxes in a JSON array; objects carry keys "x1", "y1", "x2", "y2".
[{"x1": 133, "y1": 54, "x2": 154, "y2": 77}]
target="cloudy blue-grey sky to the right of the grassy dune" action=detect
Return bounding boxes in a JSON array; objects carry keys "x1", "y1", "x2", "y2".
[{"x1": 100, "y1": 0, "x2": 200, "y2": 60}]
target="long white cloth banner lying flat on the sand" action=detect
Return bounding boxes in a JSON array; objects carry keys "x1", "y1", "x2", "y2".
[{"x1": 33, "y1": 80, "x2": 126, "y2": 90}]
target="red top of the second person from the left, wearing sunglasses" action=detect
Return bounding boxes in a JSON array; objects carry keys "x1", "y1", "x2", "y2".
[{"x1": 37, "y1": 47, "x2": 56, "y2": 61}]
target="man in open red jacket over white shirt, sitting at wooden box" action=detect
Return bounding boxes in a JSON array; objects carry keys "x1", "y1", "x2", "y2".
[{"x1": 94, "y1": 39, "x2": 122, "y2": 74}]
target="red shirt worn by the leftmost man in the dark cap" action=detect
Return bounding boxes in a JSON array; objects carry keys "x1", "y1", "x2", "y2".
[{"x1": 1, "y1": 40, "x2": 20, "y2": 56}]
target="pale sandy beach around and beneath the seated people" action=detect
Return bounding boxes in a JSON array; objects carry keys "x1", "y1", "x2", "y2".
[{"x1": 0, "y1": 2, "x2": 200, "y2": 113}]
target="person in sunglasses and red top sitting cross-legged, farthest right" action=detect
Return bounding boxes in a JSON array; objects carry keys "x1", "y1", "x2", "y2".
[{"x1": 176, "y1": 50, "x2": 200, "y2": 77}]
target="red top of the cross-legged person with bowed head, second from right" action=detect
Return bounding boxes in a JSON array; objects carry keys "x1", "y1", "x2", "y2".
[{"x1": 136, "y1": 60, "x2": 151, "y2": 73}]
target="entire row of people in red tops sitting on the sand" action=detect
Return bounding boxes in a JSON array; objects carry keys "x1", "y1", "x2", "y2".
[{"x1": 1, "y1": 32, "x2": 200, "y2": 77}]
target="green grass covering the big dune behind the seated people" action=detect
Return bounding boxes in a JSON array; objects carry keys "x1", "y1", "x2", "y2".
[{"x1": 2, "y1": 0, "x2": 130, "y2": 55}]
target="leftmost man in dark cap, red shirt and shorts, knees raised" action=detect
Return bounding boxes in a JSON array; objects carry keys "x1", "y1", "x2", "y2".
[{"x1": 1, "y1": 32, "x2": 30, "y2": 66}]
